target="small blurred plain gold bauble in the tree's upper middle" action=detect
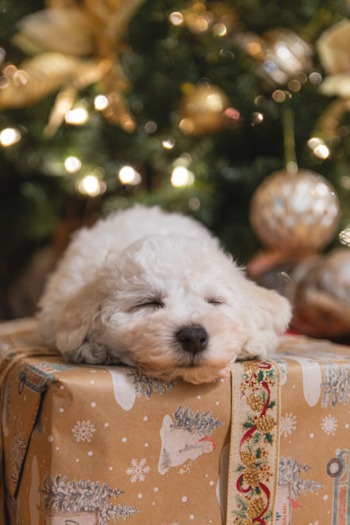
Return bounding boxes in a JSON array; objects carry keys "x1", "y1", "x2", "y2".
[{"x1": 179, "y1": 83, "x2": 229, "y2": 135}]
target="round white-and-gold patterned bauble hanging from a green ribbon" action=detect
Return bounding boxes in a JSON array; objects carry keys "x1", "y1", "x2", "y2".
[{"x1": 250, "y1": 170, "x2": 340, "y2": 251}]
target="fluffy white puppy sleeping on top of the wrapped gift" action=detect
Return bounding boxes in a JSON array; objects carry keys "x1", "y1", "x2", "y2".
[{"x1": 38, "y1": 206, "x2": 291, "y2": 383}]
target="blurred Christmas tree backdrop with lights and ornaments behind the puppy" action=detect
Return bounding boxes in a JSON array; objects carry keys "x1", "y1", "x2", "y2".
[{"x1": 0, "y1": 0, "x2": 350, "y2": 342}]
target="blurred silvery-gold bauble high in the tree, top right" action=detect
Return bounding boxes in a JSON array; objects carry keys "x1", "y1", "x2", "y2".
[{"x1": 235, "y1": 28, "x2": 313, "y2": 85}]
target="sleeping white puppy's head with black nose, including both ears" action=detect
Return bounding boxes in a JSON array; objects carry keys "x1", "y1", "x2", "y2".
[{"x1": 57, "y1": 235, "x2": 290, "y2": 383}]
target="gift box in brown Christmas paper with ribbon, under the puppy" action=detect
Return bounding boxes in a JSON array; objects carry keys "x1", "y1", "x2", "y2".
[{"x1": 0, "y1": 320, "x2": 350, "y2": 525}]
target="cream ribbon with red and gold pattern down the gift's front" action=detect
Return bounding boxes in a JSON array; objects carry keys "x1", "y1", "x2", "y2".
[{"x1": 226, "y1": 360, "x2": 280, "y2": 525}]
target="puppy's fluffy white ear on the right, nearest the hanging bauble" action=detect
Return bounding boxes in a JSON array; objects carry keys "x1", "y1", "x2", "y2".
[{"x1": 239, "y1": 278, "x2": 292, "y2": 359}]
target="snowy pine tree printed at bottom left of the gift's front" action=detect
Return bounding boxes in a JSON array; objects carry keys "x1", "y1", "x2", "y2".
[{"x1": 39, "y1": 474, "x2": 139, "y2": 525}]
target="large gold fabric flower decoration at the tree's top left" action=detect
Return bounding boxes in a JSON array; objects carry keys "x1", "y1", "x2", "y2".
[{"x1": 0, "y1": 0, "x2": 144, "y2": 135}]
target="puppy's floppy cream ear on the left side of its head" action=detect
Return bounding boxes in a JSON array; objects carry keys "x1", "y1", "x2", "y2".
[{"x1": 56, "y1": 281, "x2": 106, "y2": 363}]
